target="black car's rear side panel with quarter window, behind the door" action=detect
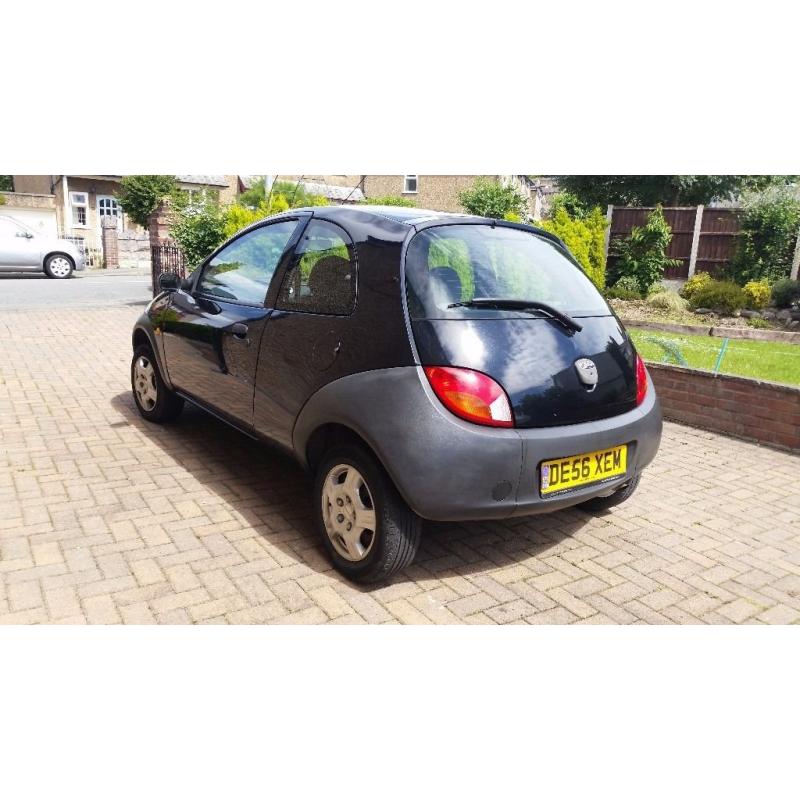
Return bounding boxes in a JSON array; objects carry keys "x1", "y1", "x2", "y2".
[{"x1": 254, "y1": 219, "x2": 358, "y2": 447}]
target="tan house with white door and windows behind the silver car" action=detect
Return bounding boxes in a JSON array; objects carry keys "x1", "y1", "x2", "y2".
[{"x1": 6, "y1": 175, "x2": 239, "y2": 251}]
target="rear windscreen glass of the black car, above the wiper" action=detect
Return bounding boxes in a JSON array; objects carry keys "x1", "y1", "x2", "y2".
[{"x1": 406, "y1": 225, "x2": 611, "y2": 319}]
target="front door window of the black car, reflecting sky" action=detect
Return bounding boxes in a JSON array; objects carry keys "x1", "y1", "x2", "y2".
[{"x1": 198, "y1": 220, "x2": 297, "y2": 305}]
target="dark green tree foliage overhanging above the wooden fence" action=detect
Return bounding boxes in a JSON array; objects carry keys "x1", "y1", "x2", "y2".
[{"x1": 558, "y1": 175, "x2": 798, "y2": 207}]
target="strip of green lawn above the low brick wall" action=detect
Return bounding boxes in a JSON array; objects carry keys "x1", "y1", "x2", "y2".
[{"x1": 629, "y1": 328, "x2": 800, "y2": 386}]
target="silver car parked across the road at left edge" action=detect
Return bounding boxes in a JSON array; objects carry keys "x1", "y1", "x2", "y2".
[{"x1": 0, "y1": 214, "x2": 86, "y2": 278}]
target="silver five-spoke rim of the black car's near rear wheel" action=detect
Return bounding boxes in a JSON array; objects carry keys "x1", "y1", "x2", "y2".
[{"x1": 322, "y1": 464, "x2": 377, "y2": 561}]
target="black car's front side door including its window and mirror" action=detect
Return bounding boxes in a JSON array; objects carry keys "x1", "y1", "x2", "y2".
[{"x1": 161, "y1": 216, "x2": 305, "y2": 428}]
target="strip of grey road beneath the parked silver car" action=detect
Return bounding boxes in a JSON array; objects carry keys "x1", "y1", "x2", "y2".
[{"x1": 0, "y1": 271, "x2": 152, "y2": 311}]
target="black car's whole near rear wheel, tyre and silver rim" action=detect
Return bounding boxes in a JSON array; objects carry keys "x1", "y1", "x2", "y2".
[{"x1": 314, "y1": 445, "x2": 422, "y2": 583}]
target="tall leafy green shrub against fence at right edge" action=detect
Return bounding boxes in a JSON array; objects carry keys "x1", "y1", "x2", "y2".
[{"x1": 727, "y1": 187, "x2": 800, "y2": 283}]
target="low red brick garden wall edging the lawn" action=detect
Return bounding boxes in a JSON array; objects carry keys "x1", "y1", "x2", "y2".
[{"x1": 647, "y1": 363, "x2": 800, "y2": 450}]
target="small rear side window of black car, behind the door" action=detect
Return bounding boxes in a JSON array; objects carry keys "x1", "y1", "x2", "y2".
[{"x1": 276, "y1": 220, "x2": 356, "y2": 315}]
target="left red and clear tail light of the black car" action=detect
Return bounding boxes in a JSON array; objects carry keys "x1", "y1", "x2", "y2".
[{"x1": 425, "y1": 367, "x2": 514, "y2": 428}]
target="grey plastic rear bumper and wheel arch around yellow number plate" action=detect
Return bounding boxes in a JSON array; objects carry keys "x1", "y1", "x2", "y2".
[{"x1": 293, "y1": 367, "x2": 661, "y2": 521}]
